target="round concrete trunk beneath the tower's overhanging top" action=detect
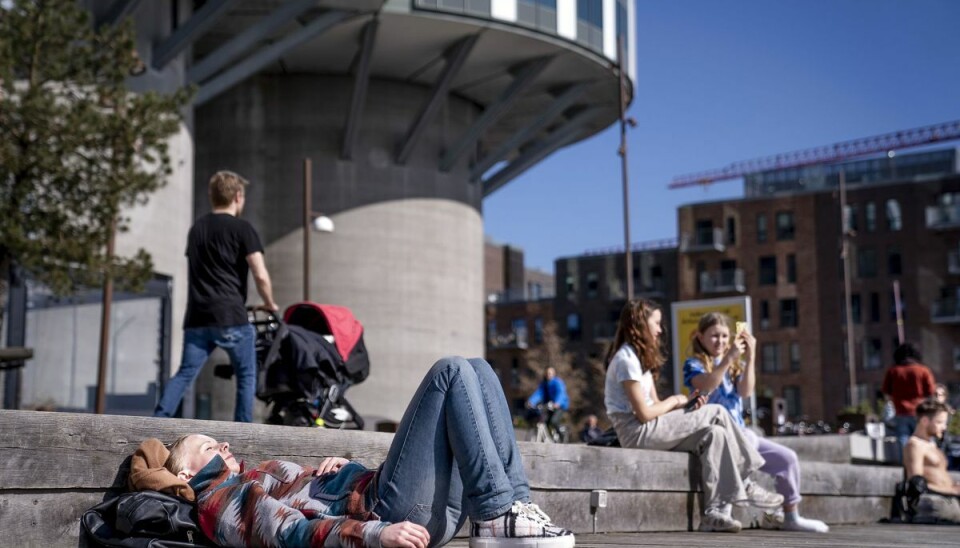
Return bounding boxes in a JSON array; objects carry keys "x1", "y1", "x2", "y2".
[{"x1": 195, "y1": 75, "x2": 483, "y2": 423}]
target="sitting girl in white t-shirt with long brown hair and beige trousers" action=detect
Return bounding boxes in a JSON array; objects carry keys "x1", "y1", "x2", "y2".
[{"x1": 604, "y1": 299, "x2": 783, "y2": 533}]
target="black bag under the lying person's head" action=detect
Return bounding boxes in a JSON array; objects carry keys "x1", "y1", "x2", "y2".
[{"x1": 80, "y1": 491, "x2": 210, "y2": 548}]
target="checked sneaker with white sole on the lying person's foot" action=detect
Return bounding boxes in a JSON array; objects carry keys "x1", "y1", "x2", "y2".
[{"x1": 470, "y1": 501, "x2": 574, "y2": 548}]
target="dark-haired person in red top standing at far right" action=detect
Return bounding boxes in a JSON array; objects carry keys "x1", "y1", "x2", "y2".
[{"x1": 882, "y1": 342, "x2": 936, "y2": 462}]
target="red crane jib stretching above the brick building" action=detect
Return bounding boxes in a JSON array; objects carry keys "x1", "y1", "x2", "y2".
[{"x1": 669, "y1": 120, "x2": 960, "y2": 189}]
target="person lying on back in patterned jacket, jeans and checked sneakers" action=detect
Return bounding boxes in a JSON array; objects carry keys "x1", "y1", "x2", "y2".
[{"x1": 164, "y1": 357, "x2": 574, "y2": 548}]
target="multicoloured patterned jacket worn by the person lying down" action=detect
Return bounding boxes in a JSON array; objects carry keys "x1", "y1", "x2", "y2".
[{"x1": 190, "y1": 455, "x2": 389, "y2": 548}]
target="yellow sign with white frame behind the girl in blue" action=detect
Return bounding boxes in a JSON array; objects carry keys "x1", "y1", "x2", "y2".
[{"x1": 670, "y1": 296, "x2": 753, "y2": 394}]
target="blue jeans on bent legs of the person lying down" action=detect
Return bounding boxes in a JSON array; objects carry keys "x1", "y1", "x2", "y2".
[{"x1": 372, "y1": 357, "x2": 530, "y2": 546}]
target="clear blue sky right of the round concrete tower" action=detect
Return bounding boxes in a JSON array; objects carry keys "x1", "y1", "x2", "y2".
[{"x1": 483, "y1": 0, "x2": 960, "y2": 271}]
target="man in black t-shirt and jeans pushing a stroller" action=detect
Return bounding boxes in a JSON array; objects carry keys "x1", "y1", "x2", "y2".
[{"x1": 154, "y1": 171, "x2": 278, "y2": 422}]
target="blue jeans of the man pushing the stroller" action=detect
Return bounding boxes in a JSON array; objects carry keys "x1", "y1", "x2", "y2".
[{"x1": 153, "y1": 324, "x2": 257, "y2": 422}]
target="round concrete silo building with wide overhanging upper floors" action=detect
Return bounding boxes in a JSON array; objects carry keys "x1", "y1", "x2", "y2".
[{"x1": 7, "y1": 0, "x2": 636, "y2": 423}]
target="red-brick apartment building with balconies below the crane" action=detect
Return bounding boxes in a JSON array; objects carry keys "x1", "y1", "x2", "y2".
[{"x1": 677, "y1": 149, "x2": 960, "y2": 421}]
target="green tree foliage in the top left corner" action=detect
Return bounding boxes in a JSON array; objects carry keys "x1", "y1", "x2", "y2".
[{"x1": 0, "y1": 0, "x2": 190, "y2": 293}]
